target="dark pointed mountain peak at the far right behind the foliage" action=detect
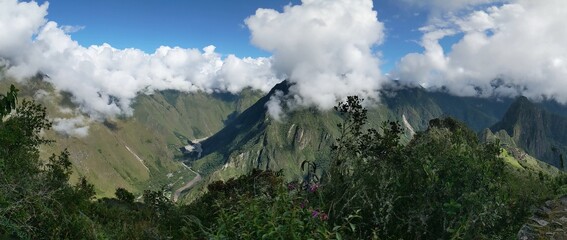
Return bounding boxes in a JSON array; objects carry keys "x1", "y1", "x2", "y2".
[{"x1": 490, "y1": 97, "x2": 567, "y2": 167}]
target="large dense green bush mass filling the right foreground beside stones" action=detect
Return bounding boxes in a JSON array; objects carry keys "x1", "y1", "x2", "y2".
[{"x1": 322, "y1": 97, "x2": 557, "y2": 239}]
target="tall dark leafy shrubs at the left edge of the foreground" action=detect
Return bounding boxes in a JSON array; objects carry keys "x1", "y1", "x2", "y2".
[{"x1": 0, "y1": 95, "x2": 95, "y2": 239}]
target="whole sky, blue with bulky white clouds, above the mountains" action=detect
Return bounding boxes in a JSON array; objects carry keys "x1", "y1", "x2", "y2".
[{"x1": 0, "y1": 0, "x2": 567, "y2": 135}]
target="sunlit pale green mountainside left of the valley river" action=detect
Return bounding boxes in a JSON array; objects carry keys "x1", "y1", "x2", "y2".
[{"x1": 0, "y1": 76, "x2": 261, "y2": 197}]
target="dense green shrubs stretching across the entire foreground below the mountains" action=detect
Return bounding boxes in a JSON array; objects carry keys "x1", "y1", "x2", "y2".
[{"x1": 0, "y1": 86, "x2": 565, "y2": 239}]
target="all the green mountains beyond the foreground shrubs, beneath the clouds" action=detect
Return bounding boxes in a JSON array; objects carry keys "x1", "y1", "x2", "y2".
[{"x1": 4, "y1": 76, "x2": 567, "y2": 200}]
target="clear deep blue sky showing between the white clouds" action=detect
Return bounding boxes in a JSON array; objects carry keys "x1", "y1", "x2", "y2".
[{"x1": 38, "y1": 0, "x2": 427, "y2": 72}]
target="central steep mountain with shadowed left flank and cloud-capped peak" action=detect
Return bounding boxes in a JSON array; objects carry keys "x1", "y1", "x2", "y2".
[{"x1": 193, "y1": 81, "x2": 340, "y2": 179}]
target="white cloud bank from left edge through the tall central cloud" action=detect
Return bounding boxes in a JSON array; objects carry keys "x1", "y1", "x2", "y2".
[{"x1": 0, "y1": 0, "x2": 384, "y2": 122}]
